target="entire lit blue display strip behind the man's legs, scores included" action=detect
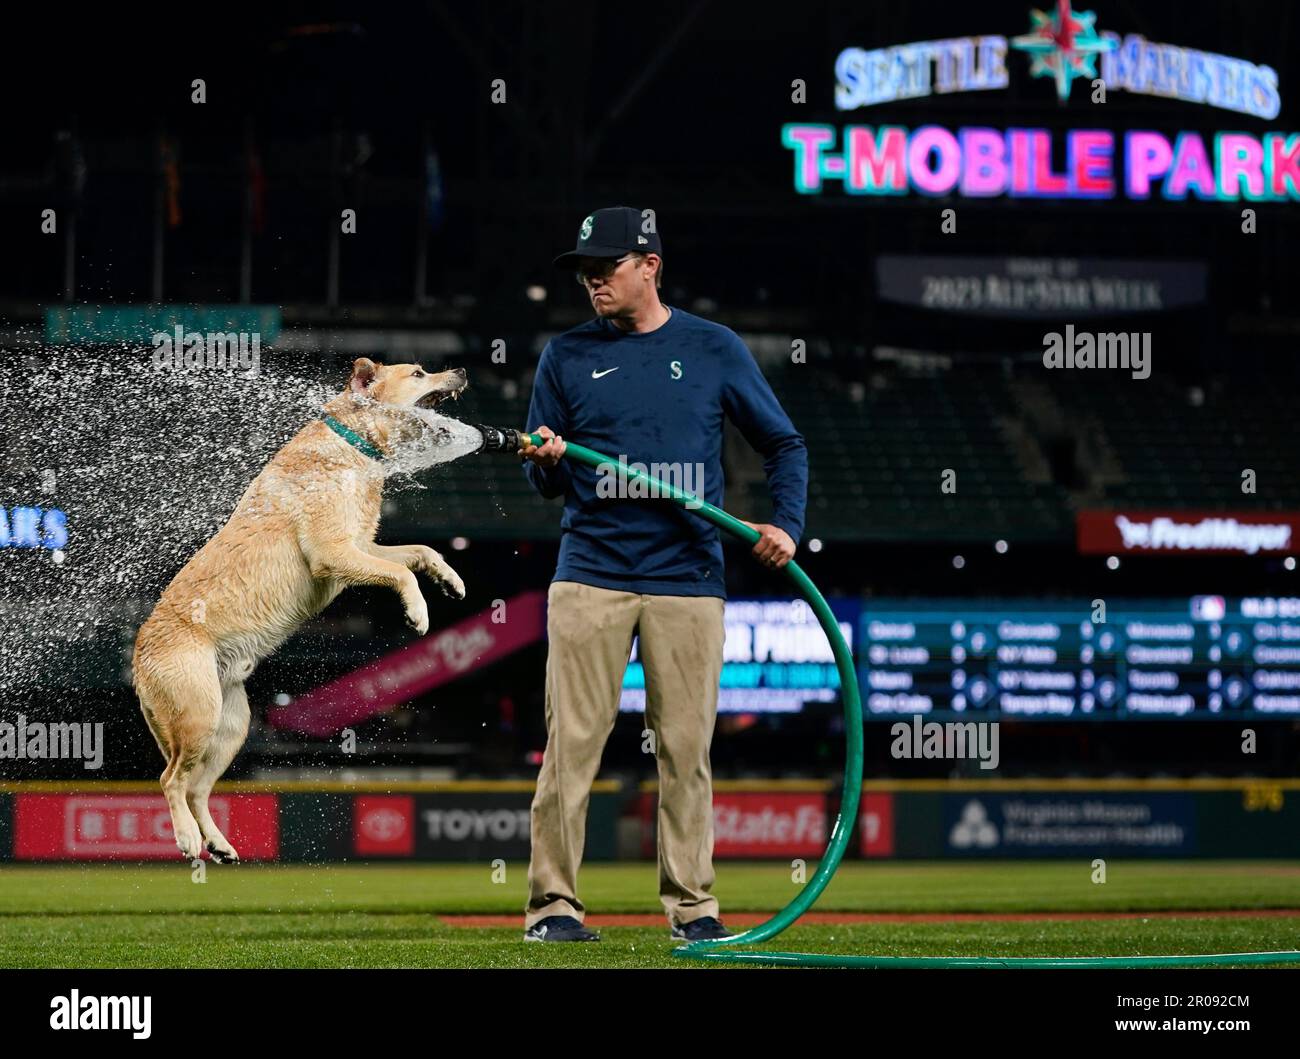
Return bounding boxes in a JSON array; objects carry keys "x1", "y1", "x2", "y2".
[{"x1": 620, "y1": 595, "x2": 1300, "y2": 721}]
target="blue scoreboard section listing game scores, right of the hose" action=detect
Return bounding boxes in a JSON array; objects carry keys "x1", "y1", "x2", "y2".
[{"x1": 857, "y1": 595, "x2": 1300, "y2": 720}]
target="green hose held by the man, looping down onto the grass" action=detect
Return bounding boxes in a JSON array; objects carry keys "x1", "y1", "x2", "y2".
[{"x1": 514, "y1": 427, "x2": 1300, "y2": 969}]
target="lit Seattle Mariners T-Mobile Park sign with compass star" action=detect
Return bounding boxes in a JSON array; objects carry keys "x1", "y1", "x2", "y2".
[{"x1": 781, "y1": 0, "x2": 1300, "y2": 201}]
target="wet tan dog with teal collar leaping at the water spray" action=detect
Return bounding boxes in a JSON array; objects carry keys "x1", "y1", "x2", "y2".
[{"x1": 131, "y1": 359, "x2": 465, "y2": 863}]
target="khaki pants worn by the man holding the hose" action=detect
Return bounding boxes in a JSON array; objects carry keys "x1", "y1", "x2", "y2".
[{"x1": 524, "y1": 581, "x2": 724, "y2": 929}]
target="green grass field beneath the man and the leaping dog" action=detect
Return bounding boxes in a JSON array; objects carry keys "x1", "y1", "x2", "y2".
[{"x1": 0, "y1": 861, "x2": 1300, "y2": 969}]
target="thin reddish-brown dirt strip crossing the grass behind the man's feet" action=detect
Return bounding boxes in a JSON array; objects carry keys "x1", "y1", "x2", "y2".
[{"x1": 438, "y1": 908, "x2": 1300, "y2": 926}]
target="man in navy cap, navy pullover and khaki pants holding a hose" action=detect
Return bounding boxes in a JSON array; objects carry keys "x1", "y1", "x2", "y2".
[{"x1": 523, "y1": 207, "x2": 807, "y2": 941}]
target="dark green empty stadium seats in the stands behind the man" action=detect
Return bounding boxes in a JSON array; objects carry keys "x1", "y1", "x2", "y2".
[{"x1": 386, "y1": 360, "x2": 1300, "y2": 542}]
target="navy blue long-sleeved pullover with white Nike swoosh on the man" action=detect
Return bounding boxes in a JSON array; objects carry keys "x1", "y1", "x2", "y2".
[{"x1": 524, "y1": 309, "x2": 807, "y2": 599}]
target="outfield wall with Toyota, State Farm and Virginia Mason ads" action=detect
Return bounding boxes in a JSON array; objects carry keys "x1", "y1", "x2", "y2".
[{"x1": 0, "y1": 780, "x2": 1300, "y2": 861}]
